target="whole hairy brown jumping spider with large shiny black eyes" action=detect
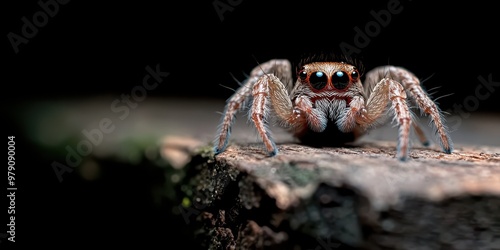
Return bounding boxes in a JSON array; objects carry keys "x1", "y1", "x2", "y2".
[{"x1": 214, "y1": 55, "x2": 452, "y2": 161}]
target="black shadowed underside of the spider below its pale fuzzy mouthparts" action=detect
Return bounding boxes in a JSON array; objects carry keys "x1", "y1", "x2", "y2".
[{"x1": 295, "y1": 120, "x2": 356, "y2": 147}]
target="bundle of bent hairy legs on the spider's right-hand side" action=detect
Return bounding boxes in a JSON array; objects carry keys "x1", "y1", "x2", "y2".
[{"x1": 356, "y1": 66, "x2": 452, "y2": 160}]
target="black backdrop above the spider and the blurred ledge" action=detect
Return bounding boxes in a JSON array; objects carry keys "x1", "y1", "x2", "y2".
[{"x1": 2, "y1": 0, "x2": 500, "y2": 111}]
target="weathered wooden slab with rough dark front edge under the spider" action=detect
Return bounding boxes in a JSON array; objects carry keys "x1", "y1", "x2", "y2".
[{"x1": 164, "y1": 140, "x2": 500, "y2": 250}]
